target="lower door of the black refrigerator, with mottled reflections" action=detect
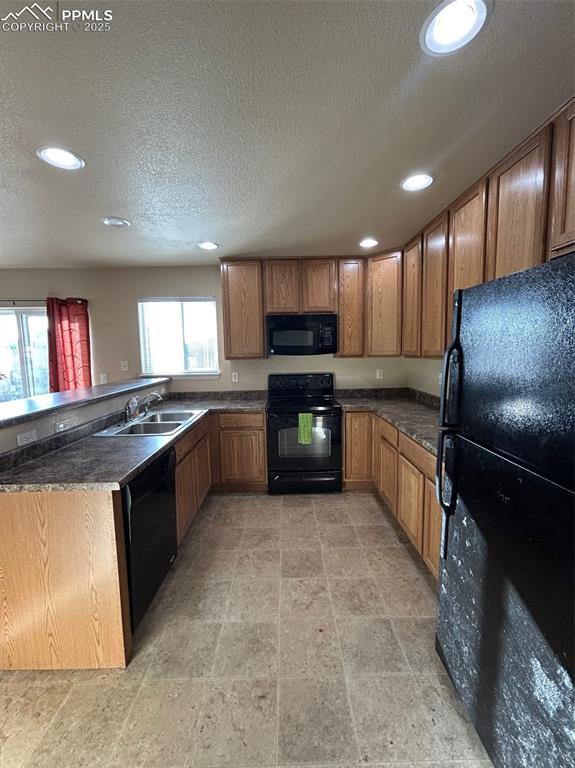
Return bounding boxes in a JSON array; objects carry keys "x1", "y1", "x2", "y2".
[{"x1": 437, "y1": 438, "x2": 575, "y2": 768}]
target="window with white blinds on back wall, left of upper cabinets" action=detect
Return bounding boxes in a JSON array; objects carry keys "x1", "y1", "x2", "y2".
[{"x1": 138, "y1": 298, "x2": 219, "y2": 376}]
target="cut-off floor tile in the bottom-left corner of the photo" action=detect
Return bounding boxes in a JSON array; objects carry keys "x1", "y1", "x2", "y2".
[{"x1": 0, "y1": 684, "x2": 70, "y2": 768}]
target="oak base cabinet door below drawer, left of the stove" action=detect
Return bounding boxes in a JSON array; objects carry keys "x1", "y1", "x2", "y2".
[{"x1": 220, "y1": 429, "x2": 266, "y2": 483}]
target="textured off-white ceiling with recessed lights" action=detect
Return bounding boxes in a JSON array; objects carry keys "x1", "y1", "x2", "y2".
[{"x1": 0, "y1": 0, "x2": 575, "y2": 267}]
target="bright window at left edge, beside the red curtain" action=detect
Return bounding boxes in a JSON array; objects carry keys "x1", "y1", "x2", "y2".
[{"x1": 0, "y1": 307, "x2": 50, "y2": 402}]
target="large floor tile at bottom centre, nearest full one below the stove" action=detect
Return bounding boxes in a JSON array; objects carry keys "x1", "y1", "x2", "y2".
[{"x1": 278, "y1": 678, "x2": 358, "y2": 764}]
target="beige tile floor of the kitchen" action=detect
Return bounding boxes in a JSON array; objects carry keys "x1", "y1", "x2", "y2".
[{"x1": 0, "y1": 493, "x2": 491, "y2": 768}]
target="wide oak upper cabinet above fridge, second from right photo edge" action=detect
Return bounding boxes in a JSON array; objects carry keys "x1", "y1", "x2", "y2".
[{"x1": 486, "y1": 125, "x2": 551, "y2": 280}]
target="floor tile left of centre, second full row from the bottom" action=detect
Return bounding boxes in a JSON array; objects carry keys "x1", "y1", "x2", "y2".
[{"x1": 214, "y1": 621, "x2": 278, "y2": 677}]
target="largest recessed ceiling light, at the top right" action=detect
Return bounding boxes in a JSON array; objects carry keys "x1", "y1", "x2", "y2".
[{"x1": 419, "y1": 0, "x2": 490, "y2": 56}]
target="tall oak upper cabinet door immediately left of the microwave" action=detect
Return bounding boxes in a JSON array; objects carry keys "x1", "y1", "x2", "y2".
[{"x1": 222, "y1": 261, "x2": 264, "y2": 358}]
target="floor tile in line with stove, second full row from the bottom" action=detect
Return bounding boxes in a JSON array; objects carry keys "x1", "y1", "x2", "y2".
[{"x1": 280, "y1": 619, "x2": 343, "y2": 677}]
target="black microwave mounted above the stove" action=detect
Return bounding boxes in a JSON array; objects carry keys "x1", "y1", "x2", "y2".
[{"x1": 266, "y1": 314, "x2": 337, "y2": 355}]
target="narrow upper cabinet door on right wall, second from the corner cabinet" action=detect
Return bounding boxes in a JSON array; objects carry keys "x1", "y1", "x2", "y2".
[{"x1": 421, "y1": 213, "x2": 447, "y2": 357}]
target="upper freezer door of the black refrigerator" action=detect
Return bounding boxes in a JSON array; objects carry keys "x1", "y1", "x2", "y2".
[{"x1": 447, "y1": 253, "x2": 575, "y2": 489}]
